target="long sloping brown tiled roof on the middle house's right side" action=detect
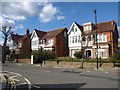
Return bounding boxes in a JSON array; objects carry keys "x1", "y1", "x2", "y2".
[{"x1": 43, "y1": 28, "x2": 67, "y2": 39}]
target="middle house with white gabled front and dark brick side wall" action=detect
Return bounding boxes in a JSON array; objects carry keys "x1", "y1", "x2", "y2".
[{"x1": 31, "y1": 28, "x2": 68, "y2": 57}]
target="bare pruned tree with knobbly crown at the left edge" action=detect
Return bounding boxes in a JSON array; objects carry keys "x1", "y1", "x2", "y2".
[{"x1": 0, "y1": 26, "x2": 12, "y2": 63}]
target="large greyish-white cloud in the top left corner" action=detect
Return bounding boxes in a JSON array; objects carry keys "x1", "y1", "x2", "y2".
[{"x1": 2, "y1": 1, "x2": 40, "y2": 21}]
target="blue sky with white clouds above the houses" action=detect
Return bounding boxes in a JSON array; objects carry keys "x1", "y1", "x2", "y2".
[{"x1": 0, "y1": 0, "x2": 120, "y2": 42}]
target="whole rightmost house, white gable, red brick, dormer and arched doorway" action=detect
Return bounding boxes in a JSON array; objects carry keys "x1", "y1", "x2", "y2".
[{"x1": 68, "y1": 20, "x2": 118, "y2": 58}]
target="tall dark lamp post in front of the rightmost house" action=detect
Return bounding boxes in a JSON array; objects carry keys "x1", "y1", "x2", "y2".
[{"x1": 93, "y1": 10, "x2": 98, "y2": 69}]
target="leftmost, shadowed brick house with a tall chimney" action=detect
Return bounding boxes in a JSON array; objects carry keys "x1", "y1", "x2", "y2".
[{"x1": 9, "y1": 29, "x2": 31, "y2": 54}]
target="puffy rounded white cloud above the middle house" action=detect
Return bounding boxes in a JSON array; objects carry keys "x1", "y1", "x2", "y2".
[{"x1": 39, "y1": 4, "x2": 59, "y2": 23}]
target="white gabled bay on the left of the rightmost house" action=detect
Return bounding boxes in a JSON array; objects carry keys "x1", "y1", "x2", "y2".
[{"x1": 67, "y1": 22, "x2": 83, "y2": 57}]
